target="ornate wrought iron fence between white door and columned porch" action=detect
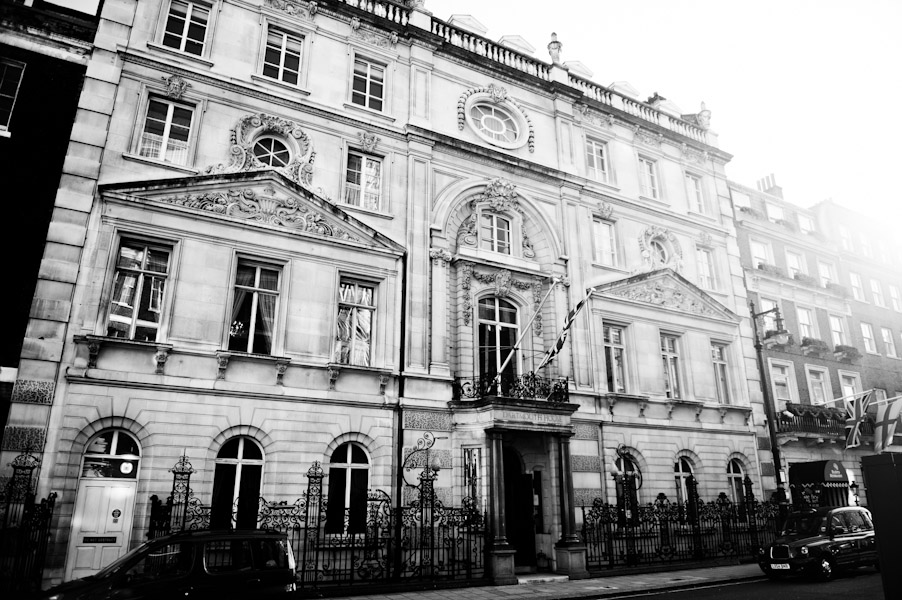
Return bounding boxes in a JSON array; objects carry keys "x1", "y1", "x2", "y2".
[{"x1": 148, "y1": 462, "x2": 486, "y2": 589}]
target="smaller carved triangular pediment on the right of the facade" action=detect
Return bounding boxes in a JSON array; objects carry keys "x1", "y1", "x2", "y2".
[{"x1": 595, "y1": 269, "x2": 740, "y2": 323}]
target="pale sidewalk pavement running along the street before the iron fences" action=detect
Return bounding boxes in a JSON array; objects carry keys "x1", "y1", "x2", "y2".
[{"x1": 329, "y1": 563, "x2": 764, "y2": 600}]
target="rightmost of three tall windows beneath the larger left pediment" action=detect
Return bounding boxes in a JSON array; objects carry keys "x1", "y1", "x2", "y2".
[{"x1": 332, "y1": 279, "x2": 376, "y2": 367}]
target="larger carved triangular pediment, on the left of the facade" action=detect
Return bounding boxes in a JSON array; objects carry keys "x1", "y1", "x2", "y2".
[{"x1": 100, "y1": 171, "x2": 404, "y2": 252}]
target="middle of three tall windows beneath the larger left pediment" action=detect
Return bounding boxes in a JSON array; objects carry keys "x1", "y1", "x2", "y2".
[{"x1": 229, "y1": 259, "x2": 281, "y2": 354}]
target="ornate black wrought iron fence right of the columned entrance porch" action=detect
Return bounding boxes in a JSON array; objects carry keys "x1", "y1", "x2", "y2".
[{"x1": 582, "y1": 477, "x2": 779, "y2": 570}]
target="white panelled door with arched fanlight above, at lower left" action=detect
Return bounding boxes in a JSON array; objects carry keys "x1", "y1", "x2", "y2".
[{"x1": 65, "y1": 429, "x2": 141, "y2": 580}]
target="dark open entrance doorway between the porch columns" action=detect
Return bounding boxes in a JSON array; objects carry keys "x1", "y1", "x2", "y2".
[{"x1": 504, "y1": 446, "x2": 541, "y2": 569}]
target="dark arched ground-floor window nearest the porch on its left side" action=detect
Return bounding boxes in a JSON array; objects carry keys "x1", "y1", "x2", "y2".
[{"x1": 326, "y1": 442, "x2": 370, "y2": 533}]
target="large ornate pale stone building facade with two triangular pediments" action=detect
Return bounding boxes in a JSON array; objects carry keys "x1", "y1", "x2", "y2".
[{"x1": 2, "y1": 0, "x2": 763, "y2": 580}]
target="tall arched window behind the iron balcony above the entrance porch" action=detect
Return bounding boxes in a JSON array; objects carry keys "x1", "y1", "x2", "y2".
[{"x1": 479, "y1": 297, "x2": 520, "y2": 385}]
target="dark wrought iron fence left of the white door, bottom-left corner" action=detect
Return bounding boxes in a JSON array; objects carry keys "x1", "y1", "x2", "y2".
[{"x1": 0, "y1": 450, "x2": 56, "y2": 597}]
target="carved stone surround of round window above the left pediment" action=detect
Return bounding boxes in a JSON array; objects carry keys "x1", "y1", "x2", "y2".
[{"x1": 205, "y1": 113, "x2": 316, "y2": 186}]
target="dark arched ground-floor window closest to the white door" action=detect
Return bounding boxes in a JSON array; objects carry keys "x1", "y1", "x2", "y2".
[{"x1": 210, "y1": 437, "x2": 263, "y2": 529}]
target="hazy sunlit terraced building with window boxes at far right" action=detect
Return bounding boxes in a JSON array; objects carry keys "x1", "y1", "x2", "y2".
[{"x1": 730, "y1": 178, "x2": 902, "y2": 504}]
